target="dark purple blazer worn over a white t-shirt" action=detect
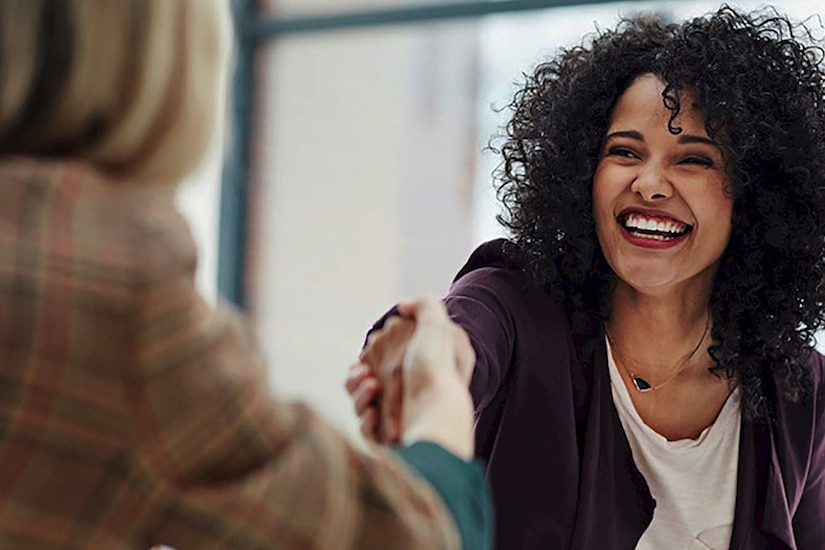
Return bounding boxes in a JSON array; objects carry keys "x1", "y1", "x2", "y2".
[{"x1": 438, "y1": 241, "x2": 825, "y2": 550}]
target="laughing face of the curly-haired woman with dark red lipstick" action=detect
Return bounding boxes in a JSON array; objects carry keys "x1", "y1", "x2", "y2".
[{"x1": 593, "y1": 74, "x2": 733, "y2": 295}]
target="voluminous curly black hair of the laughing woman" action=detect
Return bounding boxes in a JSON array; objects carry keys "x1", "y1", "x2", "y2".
[{"x1": 496, "y1": 6, "x2": 825, "y2": 416}]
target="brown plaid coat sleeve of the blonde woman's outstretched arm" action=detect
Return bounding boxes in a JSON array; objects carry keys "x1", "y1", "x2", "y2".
[{"x1": 126, "y1": 218, "x2": 460, "y2": 549}]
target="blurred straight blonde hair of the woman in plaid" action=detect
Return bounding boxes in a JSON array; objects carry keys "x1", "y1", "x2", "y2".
[{"x1": 0, "y1": 0, "x2": 226, "y2": 185}]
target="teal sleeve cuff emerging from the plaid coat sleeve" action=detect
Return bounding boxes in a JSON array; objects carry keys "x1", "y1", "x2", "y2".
[{"x1": 395, "y1": 442, "x2": 493, "y2": 550}]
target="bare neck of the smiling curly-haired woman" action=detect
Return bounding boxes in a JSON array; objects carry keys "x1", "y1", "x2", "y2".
[{"x1": 607, "y1": 281, "x2": 711, "y2": 377}]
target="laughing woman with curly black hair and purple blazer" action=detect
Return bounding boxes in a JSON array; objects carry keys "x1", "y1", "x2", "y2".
[{"x1": 348, "y1": 7, "x2": 825, "y2": 550}]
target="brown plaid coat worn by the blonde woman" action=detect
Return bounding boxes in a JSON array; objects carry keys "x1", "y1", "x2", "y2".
[{"x1": 0, "y1": 159, "x2": 459, "y2": 550}]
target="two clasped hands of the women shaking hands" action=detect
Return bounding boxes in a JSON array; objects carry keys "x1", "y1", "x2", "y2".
[{"x1": 346, "y1": 298, "x2": 475, "y2": 460}]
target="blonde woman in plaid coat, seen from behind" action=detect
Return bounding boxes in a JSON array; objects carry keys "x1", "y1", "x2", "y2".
[{"x1": 0, "y1": 0, "x2": 489, "y2": 550}]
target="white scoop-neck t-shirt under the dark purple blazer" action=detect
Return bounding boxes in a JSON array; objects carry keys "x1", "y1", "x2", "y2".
[{"x1": 607, "y1": 342, "x2": 741, "y2": 550}]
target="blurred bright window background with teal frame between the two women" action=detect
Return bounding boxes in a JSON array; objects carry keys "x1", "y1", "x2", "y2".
[{"x1": 179, "y1": 0, "x2": 825, "y2": 437}]
